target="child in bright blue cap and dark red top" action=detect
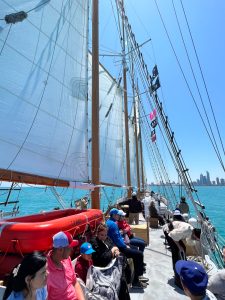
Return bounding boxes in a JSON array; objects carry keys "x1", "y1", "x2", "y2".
[{"x1": 75, "y1": 242, "x2": 95, "y2": 283}]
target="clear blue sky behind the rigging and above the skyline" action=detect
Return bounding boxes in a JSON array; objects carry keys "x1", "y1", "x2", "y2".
[{"x1": 100, "y1": 0, "x2": 225, "y2": 180}]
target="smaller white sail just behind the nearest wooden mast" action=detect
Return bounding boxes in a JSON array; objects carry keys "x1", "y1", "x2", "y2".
[{"x1": 89, "y1": 55, "x2": 126, "y2": 185}]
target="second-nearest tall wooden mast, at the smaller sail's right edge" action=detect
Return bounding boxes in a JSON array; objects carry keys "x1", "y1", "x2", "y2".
[{"x1": 121, "y1": 0, "x2": 131, "y2": 198}]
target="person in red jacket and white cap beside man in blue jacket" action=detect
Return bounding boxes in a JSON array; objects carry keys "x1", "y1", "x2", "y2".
[{"x1": 117, "y1": 209, "x2": 146, "y2": 252}]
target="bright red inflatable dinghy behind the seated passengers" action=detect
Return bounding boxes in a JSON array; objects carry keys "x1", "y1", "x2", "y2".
[{"x1": 0, "y1": 209, "x2": 103, "y2": 254}]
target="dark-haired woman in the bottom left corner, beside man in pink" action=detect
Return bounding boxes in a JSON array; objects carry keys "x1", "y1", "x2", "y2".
[{"x1": 3, "y1": 252, "x2": 47, "y2": 300}]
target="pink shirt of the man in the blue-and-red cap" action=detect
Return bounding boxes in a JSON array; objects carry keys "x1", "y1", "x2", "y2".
[{"x1": 47, "y1": 251, "x2": 78, "y2": 300}]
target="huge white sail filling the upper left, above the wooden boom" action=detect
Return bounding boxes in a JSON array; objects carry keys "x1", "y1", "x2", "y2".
[{"x1": 0, "y1": 0, "x2": 88, "y2": 181}]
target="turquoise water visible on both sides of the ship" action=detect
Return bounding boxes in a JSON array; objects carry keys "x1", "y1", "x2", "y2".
[{"x1": 0, "y1": 186, "x2": 225, "y2": 238}]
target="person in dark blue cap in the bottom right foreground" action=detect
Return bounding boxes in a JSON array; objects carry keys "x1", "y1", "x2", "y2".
[{"x1": 175, "y1": 260, "x2": 216, "y2": 300}]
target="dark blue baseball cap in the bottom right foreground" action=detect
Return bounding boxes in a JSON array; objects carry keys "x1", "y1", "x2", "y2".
[{"x1": 175, "y1": 260, "x2": 208, "y2": 295}]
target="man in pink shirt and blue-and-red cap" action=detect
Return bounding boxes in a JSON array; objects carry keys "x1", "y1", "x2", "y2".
[{"x1": 47, "y1": 231, "x2": 85, "y2": 300}]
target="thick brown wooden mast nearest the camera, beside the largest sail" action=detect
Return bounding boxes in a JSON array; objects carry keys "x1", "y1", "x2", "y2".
[{"x1": 91, "y1": 0, "x2": 100, "y2": 208}]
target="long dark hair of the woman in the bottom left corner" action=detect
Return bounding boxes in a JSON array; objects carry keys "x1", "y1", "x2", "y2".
[{"x1": 3, "y1": 252, "x2": 47, "y2": 300}]
